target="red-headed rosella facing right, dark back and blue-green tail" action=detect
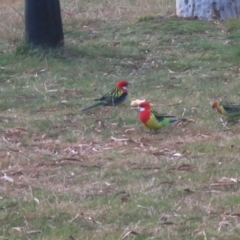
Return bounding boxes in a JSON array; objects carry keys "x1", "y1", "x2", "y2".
[{"x1": 82, "y1": 80, "x2": 128, "y2": 111}]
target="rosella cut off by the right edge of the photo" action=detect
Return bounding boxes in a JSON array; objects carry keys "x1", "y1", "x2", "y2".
[{"x1": 212, "y1": 101, "x2": 240, "y2": 118}]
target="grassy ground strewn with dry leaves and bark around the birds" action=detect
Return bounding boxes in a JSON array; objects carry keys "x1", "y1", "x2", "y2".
[{"x1": 0, "y1": 0, "x2": 240, "y2": 240}]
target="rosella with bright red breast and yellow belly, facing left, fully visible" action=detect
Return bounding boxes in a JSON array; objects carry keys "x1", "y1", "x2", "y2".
[{"x1": 138, "y1": 101, "x2": 187, "y2": 130}]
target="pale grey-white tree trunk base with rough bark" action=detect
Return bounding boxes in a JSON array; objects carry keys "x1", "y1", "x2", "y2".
[{"x1": 176, "y1": 0, "x2": 240, "y2": 20}]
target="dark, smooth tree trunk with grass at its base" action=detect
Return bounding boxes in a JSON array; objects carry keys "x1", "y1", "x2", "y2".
[{"x1": 25, "y1": 0, "x2": 64, "y2": 47}]
